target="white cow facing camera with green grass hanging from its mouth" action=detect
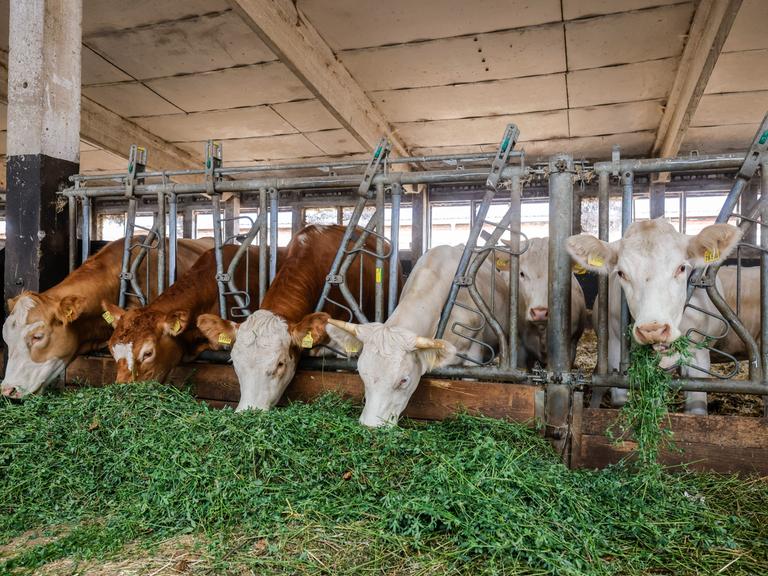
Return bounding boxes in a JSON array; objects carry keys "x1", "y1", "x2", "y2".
[{"x1": 566, "y1": 218, "x2": 741, "y2": 414}]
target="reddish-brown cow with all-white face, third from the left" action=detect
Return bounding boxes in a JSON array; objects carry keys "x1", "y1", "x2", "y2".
[{"x1": 197, "y1": 225, "x2": 399, "y2": 410}]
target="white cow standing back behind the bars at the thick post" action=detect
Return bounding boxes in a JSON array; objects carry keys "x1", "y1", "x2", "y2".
[{"x1": 496, "y1": 238, "x2": 587, "y2": 369}]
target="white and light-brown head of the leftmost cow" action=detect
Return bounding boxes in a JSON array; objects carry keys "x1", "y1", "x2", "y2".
[{"x1": 0, "y1": 292, "x2": 86, "y2": 398}]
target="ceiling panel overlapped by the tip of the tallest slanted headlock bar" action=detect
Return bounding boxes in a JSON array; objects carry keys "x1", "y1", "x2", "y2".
[{"x1": 395, "y1": 110, "x2": 568, "y2": 148}]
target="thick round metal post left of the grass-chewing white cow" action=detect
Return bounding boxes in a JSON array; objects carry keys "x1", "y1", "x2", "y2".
[{"x1": 545, "y1": 154, "x2": 573, "y2": 454}]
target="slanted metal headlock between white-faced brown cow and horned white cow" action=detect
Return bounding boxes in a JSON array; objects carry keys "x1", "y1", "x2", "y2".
[{"x1": 315, "y1": 138, "x2": 392, "y2": 324}]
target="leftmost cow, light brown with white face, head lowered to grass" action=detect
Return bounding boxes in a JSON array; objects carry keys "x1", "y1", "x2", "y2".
[{"x1": 2, "y1": 238, "x2": 213, "y2": 398}]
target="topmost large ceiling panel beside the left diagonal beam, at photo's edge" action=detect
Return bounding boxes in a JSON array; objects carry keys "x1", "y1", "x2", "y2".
[{"x1": 298, "y1": 0, "x2": 560, "y2": 51}]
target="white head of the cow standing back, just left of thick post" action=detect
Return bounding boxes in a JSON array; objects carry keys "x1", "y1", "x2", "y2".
[{"x1": 496, "y1": 238, "x2": 549, "y2": 322}]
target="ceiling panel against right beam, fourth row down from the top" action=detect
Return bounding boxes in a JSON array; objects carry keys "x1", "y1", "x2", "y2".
[{"x1": 569, "y1": 100, "x2": 663, "y2": 137}]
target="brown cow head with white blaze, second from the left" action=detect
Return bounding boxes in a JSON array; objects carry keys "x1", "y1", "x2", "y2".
[{"x1": 101, "y1": 302, "x2": 189, "y2": 382}]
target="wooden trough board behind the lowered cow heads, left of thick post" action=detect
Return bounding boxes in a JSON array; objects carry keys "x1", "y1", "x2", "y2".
[{"x1": 66, "y1": 356, "x2": 536, "y2": 423}]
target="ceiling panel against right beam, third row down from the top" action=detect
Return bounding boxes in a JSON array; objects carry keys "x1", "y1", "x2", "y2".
[{"x1": 568, "y1": 58, "x2": 678, "y2": 108}]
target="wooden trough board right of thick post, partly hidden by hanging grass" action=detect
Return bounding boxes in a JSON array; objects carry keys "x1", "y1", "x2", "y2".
[{"x1": 571, "y1": 408, "x2": 768, "y2": 475}]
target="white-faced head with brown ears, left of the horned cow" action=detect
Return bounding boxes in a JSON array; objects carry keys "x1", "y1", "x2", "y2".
[{"x1": 197, "y1": 310, "x2": 328, "y2": 411}]
